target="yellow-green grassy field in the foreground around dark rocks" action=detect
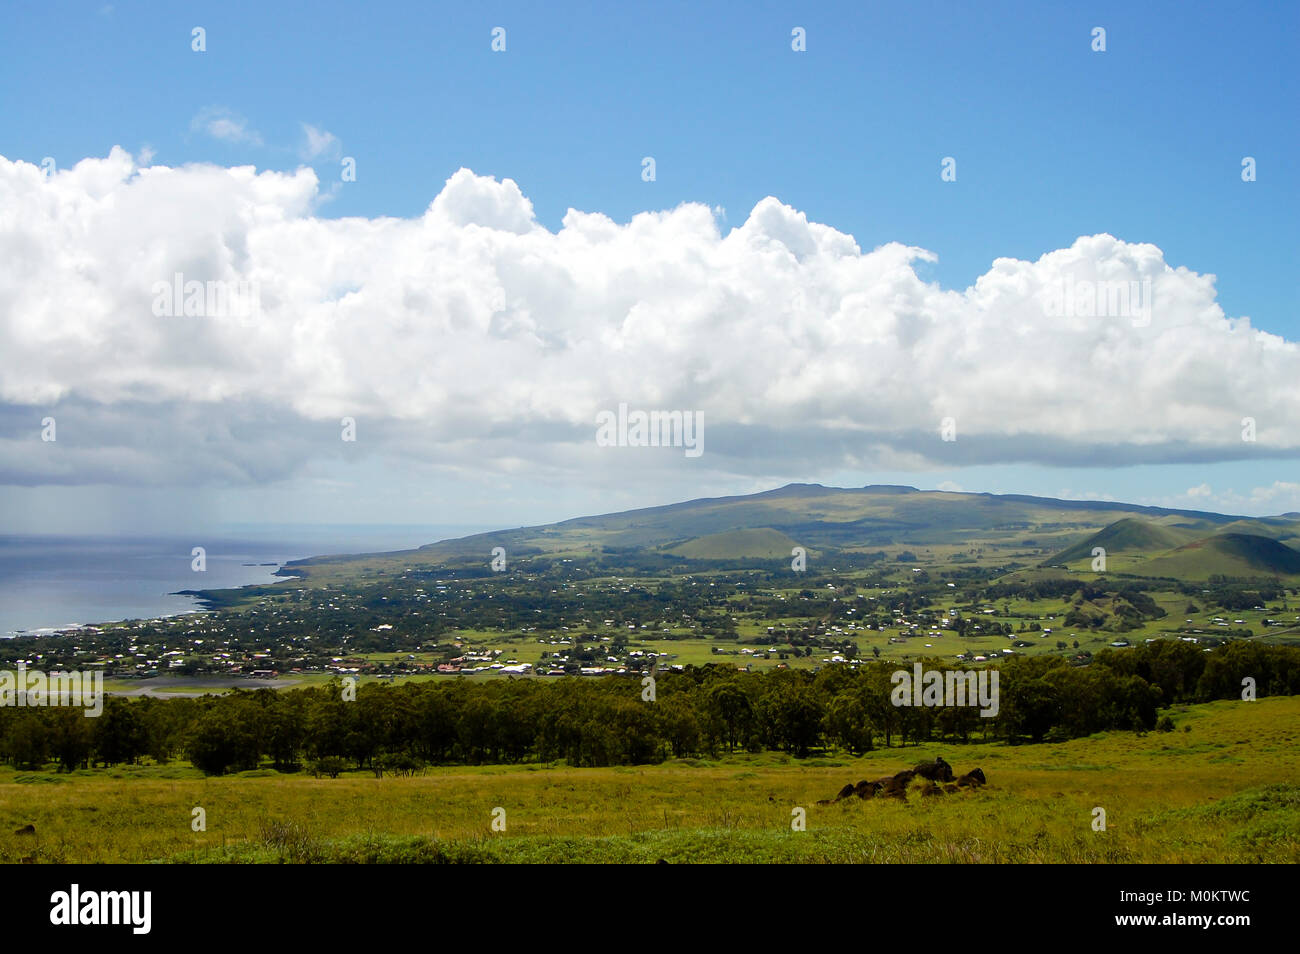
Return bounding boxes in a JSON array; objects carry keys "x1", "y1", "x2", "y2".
[{"x1": 0, "y1": 698, "x2": 1300, "y2": 863}]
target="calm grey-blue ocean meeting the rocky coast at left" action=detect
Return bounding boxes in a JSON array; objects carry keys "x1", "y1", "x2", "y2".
[{"x1": 0, "y1": 525, "x2": 490, "y2": 637}]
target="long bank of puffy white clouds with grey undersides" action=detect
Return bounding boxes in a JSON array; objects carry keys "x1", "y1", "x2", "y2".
[{"x1": 0, "y1": 149, "x2": 1300, "y2": 485}]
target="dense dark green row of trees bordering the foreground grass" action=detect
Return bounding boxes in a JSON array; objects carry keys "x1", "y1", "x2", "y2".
[{"x1": 0, "y1": 641, "x2": 1300, "y2": 775}]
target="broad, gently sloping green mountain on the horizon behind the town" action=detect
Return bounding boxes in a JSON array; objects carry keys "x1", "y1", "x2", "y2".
[{"x1": 284, "y1": 483, "x2": 1300, "y2": 568}]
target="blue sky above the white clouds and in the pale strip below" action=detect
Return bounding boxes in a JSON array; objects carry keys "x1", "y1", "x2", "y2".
[{"x1": 0, "y1": 1, "x2": 1300, "y2": 535}]
